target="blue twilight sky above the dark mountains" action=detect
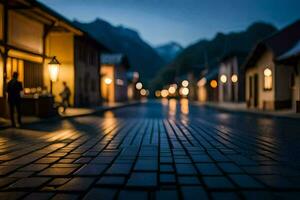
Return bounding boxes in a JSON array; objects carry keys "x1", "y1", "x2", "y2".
[{"x1": 40, "y1": 0, "x2": 300, "y2": 46}]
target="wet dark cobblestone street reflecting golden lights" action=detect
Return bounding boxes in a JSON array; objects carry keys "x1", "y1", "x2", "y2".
[{"x1": 0, "y1": 100, "x2": 300, "y2": 200}]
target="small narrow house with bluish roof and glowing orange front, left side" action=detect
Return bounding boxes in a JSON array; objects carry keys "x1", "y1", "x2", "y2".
[{"x1": 100, "y1": 54, "x2": 129, "y2": 103}]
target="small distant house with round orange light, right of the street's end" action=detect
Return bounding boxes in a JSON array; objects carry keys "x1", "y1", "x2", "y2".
[{"x1": 197, "y1": 68, "x2": 219, "y2": 103}]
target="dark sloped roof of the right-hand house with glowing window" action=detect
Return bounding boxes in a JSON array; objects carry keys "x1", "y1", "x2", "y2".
[{"x1": 245, "y1": 20, "x2": 300, "y2": 68}]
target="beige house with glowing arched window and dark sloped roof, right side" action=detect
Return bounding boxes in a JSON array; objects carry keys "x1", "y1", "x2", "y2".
[{"x1": 245, "y1": 21, "x2": 300, "y2": 110}]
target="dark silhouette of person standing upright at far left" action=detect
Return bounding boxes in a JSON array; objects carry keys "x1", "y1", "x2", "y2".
[{"x1": 6, "y1": 72, "x2": 23, "y2": 127}]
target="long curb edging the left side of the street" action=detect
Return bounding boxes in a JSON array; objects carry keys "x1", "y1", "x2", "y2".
[{"x1": 0, "y1": 101, "x2": 143, "y2": 130}]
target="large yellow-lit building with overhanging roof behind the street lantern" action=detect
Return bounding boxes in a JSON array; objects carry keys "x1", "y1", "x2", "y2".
[{"x1": 0, "y1": 0, "x2": 106, "y2": 116}]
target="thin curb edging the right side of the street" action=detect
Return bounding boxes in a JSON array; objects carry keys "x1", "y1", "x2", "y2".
[{"x1": 192, "y1": 103, "x2": 300, "y2": 119}]
